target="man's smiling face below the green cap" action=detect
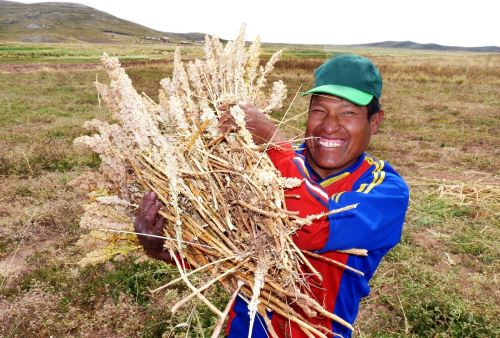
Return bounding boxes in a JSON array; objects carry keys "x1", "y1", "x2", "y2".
[{"x1": 306, "y1": 94, "x2": 384, "y2": 178}]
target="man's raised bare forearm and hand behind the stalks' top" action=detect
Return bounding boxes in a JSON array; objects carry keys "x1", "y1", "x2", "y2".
[{"x1": 218, "y1": 104, "x2": 286, "y2": 144}]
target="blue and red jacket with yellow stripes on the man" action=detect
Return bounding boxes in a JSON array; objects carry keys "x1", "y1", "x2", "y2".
[{"x1": 226, "y1": 147, "x2": 409, "y2": 338}]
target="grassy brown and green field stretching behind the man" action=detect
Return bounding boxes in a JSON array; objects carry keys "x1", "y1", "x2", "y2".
[{"x1": 0, "y1": 44, "x2": 500, "y2": 337}]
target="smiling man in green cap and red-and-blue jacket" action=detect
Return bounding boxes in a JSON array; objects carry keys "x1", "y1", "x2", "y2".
[{"x1": 135, "y1": 54, "x2": 409, "y2": 338}]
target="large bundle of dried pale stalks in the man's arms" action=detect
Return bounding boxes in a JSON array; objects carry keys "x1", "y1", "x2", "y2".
[{"x1": 72, "y1": 25, "x2": 362, "y2": 337}]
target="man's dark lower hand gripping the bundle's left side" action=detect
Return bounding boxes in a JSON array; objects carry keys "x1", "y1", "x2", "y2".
[{"x1": 134, "y1": 192, "x2": 172, "y2": 262}]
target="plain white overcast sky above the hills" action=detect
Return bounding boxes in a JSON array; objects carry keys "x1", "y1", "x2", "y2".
[{"x1": 19, "y1": 0, "x2": 500, "y2": 47}]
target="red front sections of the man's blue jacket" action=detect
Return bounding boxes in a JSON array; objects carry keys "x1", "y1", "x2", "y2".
[{"x1": 267, "y1": 145, "x2": 371, "y2": 338}]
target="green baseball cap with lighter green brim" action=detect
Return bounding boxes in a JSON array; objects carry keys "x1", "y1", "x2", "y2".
[{"x1": 302, "y1": 54, "x2": 382, "y2": 106}]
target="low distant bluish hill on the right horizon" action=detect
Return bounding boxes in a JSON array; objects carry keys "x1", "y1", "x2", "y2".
[{"x1": 350, "y1": 41, "x2": 500, "y2": 53}]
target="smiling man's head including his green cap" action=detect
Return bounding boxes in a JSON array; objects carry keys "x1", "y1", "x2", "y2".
[{"x1": 305, "y1": 55, "x2": 384, "y2": 176}]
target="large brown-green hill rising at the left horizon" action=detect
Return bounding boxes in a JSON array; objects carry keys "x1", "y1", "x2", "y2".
[{"x1": 0, "y1": 0, "x2": 186, "y2": 43}]
